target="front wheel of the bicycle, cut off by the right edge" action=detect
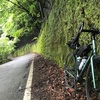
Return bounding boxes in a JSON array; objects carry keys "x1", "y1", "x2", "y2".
[{"x1": 86, "y1": 55, "x2": 100, "y2": 100}]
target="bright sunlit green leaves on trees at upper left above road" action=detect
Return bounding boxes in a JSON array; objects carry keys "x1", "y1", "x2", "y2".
[{"x1": 0, "y1": 0, "x2": 42, "y2": 63}]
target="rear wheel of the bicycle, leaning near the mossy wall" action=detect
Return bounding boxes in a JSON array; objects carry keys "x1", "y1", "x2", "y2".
[{"x1": 64, "y1": 53, "x2": 75, "y2": 88}]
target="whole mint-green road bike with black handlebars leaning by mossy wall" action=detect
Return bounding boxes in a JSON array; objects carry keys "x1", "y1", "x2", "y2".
[{"x1": 64, "y1": 22, "x2": 100, "y2": 100}]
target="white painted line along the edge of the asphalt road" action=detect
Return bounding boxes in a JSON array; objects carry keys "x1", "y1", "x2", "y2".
[{"x1": 23, "y1": 61, "x2": 34, "y2": 100}]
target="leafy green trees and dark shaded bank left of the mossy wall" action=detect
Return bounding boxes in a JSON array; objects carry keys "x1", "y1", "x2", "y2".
[{"x1": 0, "y1": 0, "x2": 54, "y2": 64}]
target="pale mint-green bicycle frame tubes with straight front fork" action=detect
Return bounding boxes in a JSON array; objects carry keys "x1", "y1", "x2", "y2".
[{"x1": 76, "y1": 34, "x2": 97, "y2": 90}]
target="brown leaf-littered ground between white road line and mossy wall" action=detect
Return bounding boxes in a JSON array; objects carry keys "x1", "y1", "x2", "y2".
[{"x1": 32, "y1": 55, "x2": 85, "y2": 100}]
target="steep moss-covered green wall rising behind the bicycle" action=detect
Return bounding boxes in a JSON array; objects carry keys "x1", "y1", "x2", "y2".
[{"x1": 37, "y1": 0, "x2": 100, "y2": 66}]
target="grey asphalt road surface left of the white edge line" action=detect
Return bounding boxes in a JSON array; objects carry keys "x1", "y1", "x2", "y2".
[{"x1": 0, "y1": 54, "x2": 34, "y2": 100}]
